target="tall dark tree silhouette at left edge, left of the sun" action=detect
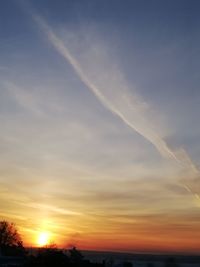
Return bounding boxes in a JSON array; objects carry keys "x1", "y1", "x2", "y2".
[{"x1": 0, "y1": 221, "x2": 25, "y2": 256}]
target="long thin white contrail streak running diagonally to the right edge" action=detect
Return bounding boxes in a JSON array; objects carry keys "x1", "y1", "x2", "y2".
[{"x1": 17, "y1": 0, "x2": 200, "y2": 198}]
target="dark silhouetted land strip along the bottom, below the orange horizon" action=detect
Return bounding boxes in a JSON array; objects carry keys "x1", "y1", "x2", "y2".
[{"x1": 0, "y1": 247, "x2": 200, "y2": 267}]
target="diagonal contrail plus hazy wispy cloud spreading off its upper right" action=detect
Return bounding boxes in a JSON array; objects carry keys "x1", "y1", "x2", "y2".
[{"x1": 27, "y1": 14, "x2": 200, "y2": 203}]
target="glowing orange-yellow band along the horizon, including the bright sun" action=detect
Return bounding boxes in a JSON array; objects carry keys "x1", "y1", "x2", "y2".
[{"x1": 17, "y1": 220, "x2": 200, "y2": 253}]
